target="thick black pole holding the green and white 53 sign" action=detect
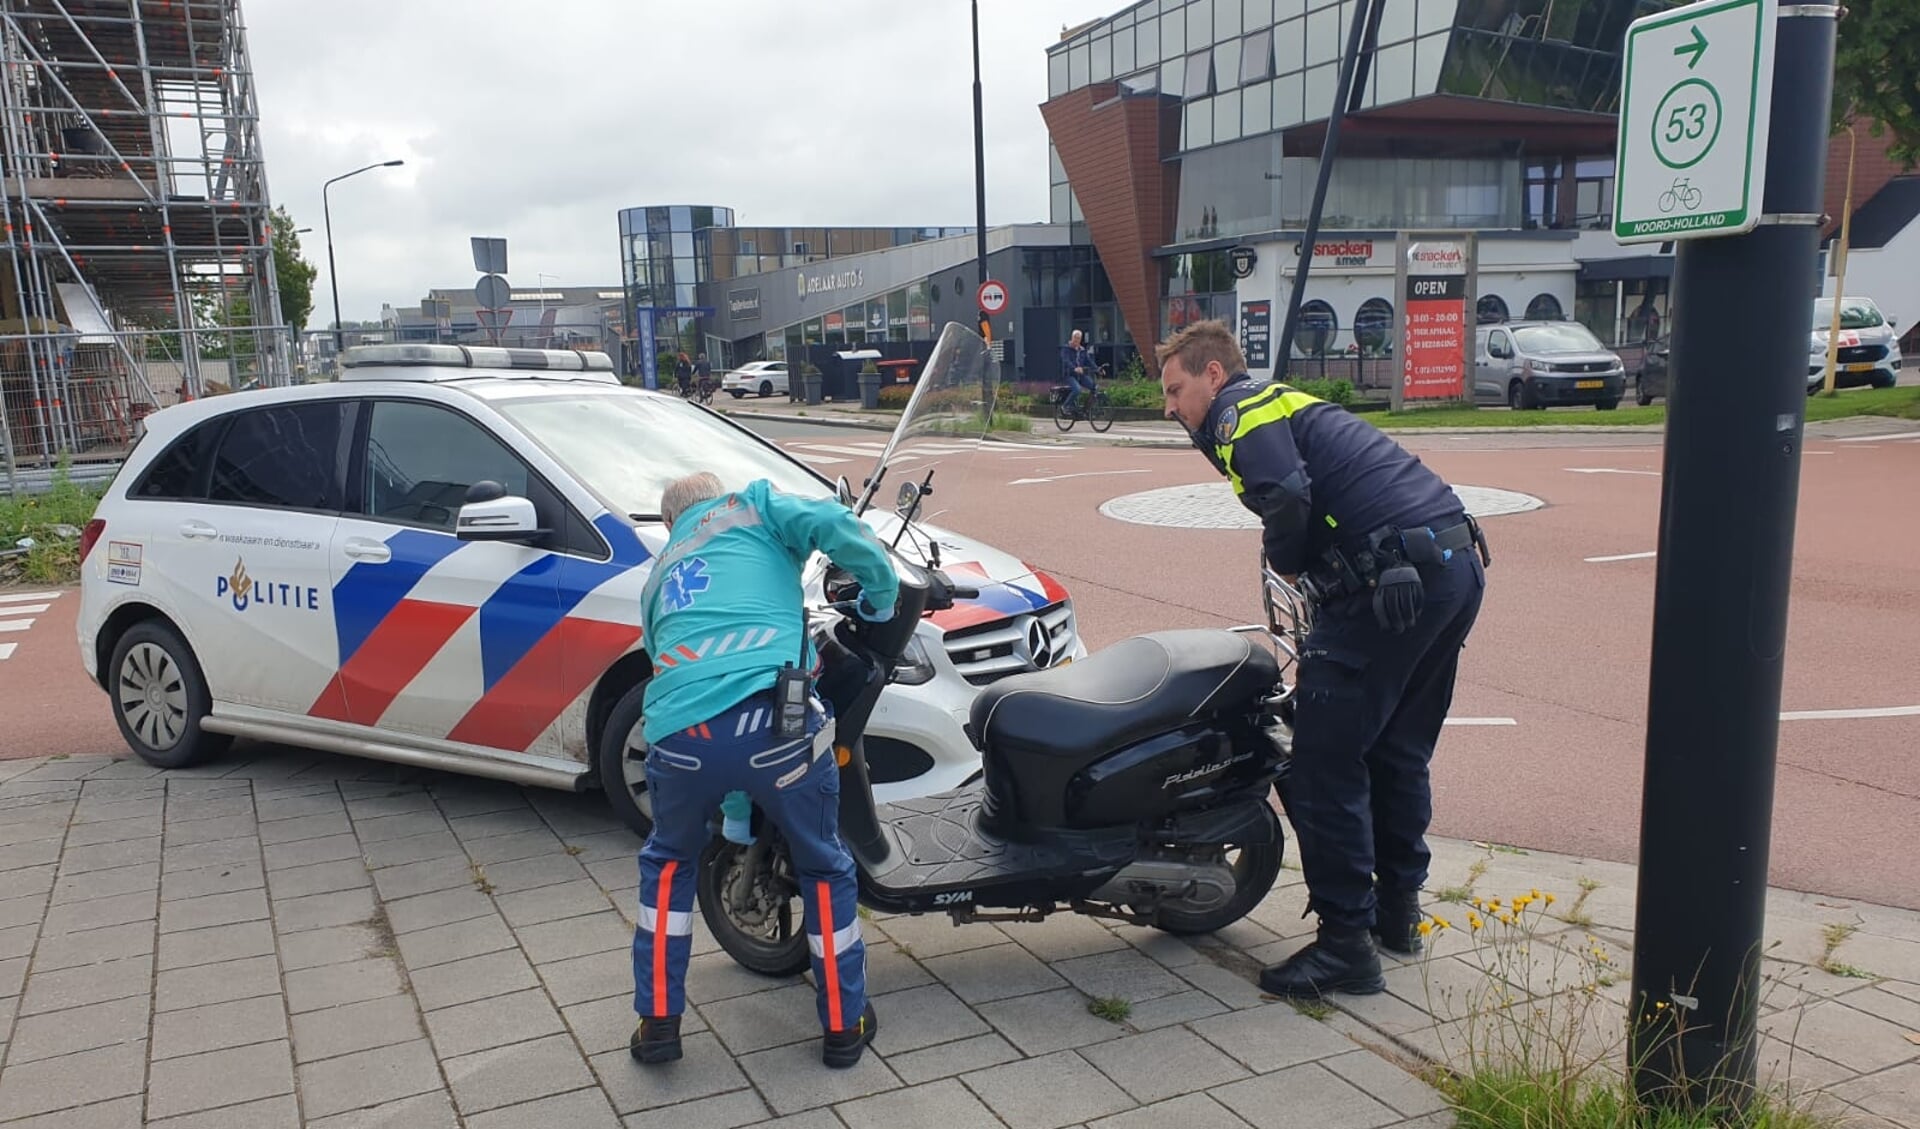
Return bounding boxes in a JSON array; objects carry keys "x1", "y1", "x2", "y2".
[{"x1": 1628, "y1": 4, "x2": 1837, "y2": 1108}]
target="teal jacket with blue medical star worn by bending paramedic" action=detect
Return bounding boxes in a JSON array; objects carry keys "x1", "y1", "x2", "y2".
[{"x1": 641, "y1": 478, "x2": 900, "y2": 745}]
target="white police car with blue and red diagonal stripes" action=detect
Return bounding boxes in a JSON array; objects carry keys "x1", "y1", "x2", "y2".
[{"x1": 79, "y1": 344, "x2": 1085, "y2": 833}]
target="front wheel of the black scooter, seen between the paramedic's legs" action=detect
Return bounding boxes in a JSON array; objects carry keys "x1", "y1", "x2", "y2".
[{"x1": 699, "y1": 829, "x2": 808, "y2": 977}]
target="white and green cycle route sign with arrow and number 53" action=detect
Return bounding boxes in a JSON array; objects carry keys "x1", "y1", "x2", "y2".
[{"x1": 1613, "y1": 0, "x2": 1780, "y2": 244}]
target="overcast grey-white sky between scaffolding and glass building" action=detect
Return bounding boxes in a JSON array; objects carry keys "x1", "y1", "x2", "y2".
[{"x1": 244, "y1": 0, "x2": 1125, "y2": 328}]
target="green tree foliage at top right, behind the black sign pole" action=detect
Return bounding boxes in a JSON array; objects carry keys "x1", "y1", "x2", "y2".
[{"x1": 1834, "y1": 0, "x2": 1920, "y2": 169}]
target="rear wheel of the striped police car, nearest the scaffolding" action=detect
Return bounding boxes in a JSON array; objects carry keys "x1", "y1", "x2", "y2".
[{"x1": 108, "y1": 620, "x2": 232, "y2": 768}]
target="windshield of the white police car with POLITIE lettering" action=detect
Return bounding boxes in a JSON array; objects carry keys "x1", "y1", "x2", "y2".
[{"x1": 495, "y1": 392, "x2": 833, "y2": 518}]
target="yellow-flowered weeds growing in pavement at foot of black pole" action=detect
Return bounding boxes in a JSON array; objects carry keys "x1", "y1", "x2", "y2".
[{"x1": 1419, "y1": 879, "x2": 1836, "y2": 1129}]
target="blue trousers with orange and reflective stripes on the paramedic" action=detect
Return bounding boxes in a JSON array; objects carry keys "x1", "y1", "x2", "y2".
[{"x1": 634, "y1": 691, "x2": 866, "y2": 1031}]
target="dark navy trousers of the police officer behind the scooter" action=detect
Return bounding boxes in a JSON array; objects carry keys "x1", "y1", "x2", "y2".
[{"x1": 1281, "y1": 541, "x2": 1486, "y2": 929}]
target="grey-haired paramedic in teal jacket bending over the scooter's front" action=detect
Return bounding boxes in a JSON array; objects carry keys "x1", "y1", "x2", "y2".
[{"x1": 628, "y1": 472, "x2": 900, "y2": 1068}]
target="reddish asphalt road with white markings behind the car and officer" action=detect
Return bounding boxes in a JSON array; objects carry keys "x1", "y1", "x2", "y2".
[{"x1": 15, "y1": 422, "x2": 1920, "y2": 908}]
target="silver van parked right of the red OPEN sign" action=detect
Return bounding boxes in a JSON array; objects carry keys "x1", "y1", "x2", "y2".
[{"x1": 1473, "y1": 321, "x2": 1626, "y2": 411}]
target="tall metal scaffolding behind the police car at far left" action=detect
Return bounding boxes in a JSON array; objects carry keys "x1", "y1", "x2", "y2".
[{"x1": 0, "y1": 0, "x2": 292, "y2": 488}]
